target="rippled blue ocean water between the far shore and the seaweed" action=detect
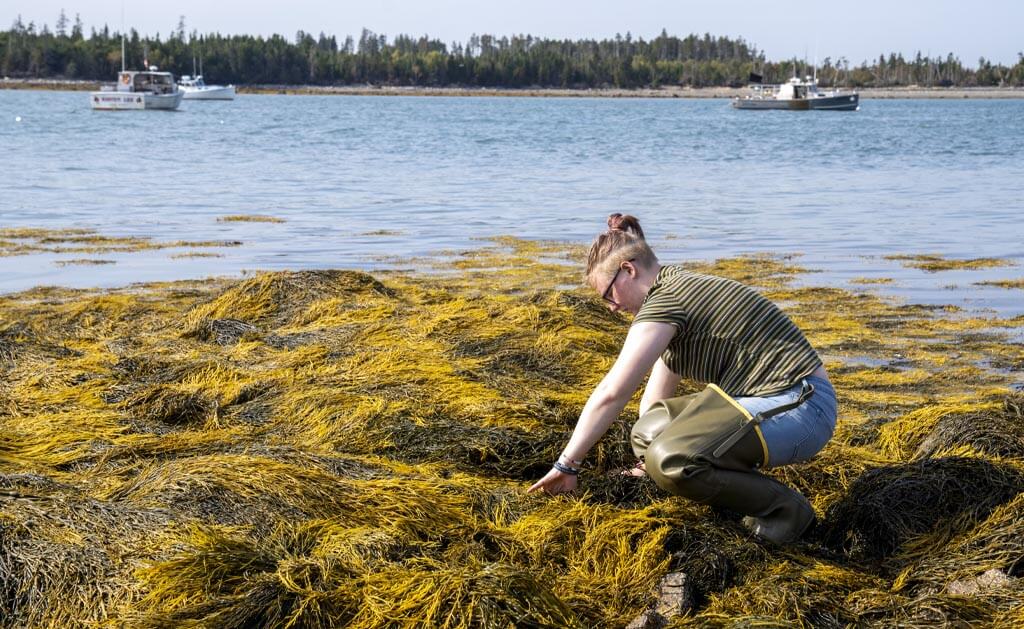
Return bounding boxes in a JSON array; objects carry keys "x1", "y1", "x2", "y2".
[{"x1": 0, "y1": 91, "x2": 1024, "y2": 315}]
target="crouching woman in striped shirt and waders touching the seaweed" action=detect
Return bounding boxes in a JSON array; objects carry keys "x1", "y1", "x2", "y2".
[{"x1": 529, "y1": 214, "x2": 836, "y2": 543}]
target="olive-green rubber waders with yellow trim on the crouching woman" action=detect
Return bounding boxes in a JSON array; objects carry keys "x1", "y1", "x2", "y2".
[{"x1": 631, "y1": 382, "x2": 814, "y2": 543}]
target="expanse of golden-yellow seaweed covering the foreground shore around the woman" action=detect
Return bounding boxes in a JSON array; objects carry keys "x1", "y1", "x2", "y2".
[{"x1": 0, "y1": 241, "x2": 1024, "y2": 627}]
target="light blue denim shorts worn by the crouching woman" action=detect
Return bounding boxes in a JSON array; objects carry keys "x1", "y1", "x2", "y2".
[{"x1": 736, "y1": 376, "x2": 837, "y2": 467}]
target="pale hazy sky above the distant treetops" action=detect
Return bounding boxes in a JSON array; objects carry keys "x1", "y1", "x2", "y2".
[{"x1": 8, "y1": 0, "x2": 1024, "y2": 67}]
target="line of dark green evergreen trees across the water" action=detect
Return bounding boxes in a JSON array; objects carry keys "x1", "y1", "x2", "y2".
[{"x1": 6, "y1": 11, "x2": 1024, "y2": 88}]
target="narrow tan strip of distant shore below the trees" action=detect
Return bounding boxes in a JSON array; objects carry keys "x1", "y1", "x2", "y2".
[{"x1": 0, "y1": 77, "x2": 1024, "y2": 98}]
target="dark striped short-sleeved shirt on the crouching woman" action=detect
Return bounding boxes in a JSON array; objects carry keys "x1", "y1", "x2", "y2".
[{"x1": 633, "y1": 265, "x2": 821, "y2": 396}]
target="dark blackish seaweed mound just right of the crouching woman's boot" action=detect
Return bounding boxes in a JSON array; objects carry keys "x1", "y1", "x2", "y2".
[{"x1": 821, "y1": 457, "x2": 1024, "y2": 559}]
